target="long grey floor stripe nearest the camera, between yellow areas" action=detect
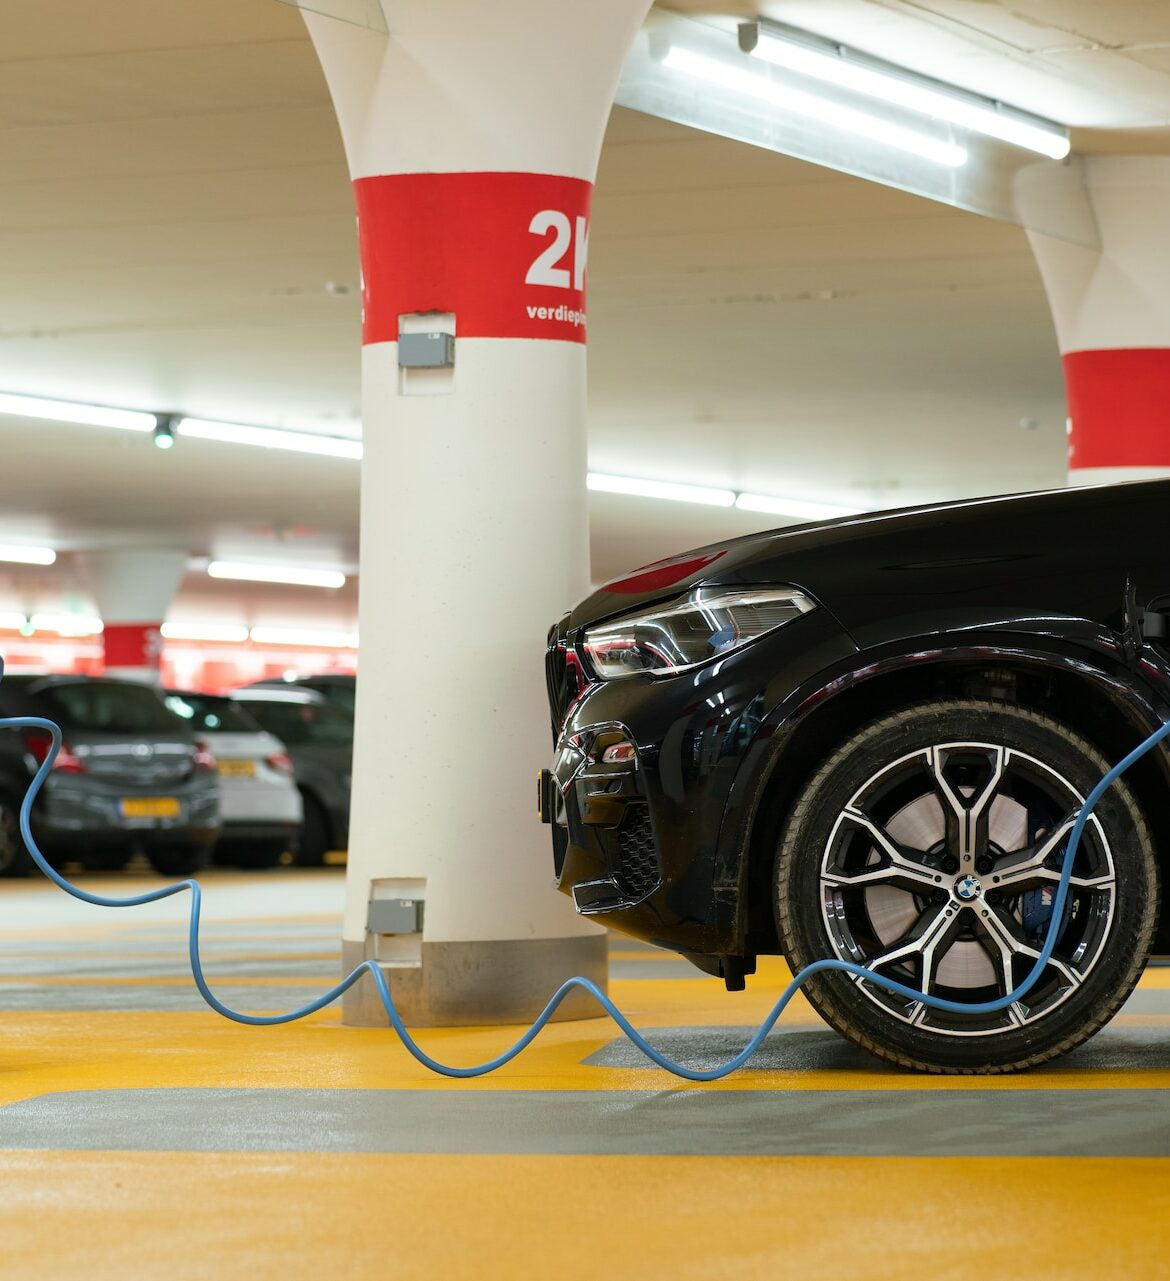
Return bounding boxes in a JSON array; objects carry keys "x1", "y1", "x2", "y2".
[{"x1": 0, "y1": 1089, "x2": 1170, "y2": 1157}]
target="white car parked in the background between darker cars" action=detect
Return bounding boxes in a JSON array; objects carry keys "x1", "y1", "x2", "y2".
[{"x1": 164, "y1": 689, "x2": 304, "y2": 867}]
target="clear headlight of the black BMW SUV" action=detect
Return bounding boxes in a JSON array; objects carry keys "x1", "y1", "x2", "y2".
[{"x1": 584, "y1": 587, "x2": 815, "y2": 680}]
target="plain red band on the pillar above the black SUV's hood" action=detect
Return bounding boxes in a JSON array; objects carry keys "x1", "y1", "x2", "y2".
[{"x1": 1064, "y1": 347, "x2": 1170, "y2": 468}]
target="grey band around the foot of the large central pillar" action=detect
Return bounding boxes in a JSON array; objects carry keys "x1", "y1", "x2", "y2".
[{"x1": 341, "y1": 934, "x2": 607, "y2": 1027}]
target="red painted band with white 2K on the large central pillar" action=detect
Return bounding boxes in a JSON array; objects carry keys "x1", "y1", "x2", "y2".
[{"x1": 354, "y1": 173, "x2": 593, "y2": 343}]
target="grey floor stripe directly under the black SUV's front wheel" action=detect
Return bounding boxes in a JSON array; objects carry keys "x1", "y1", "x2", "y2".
[{"x1": 583, "y1": 1025, "x2": 1170, "y2": 1077}]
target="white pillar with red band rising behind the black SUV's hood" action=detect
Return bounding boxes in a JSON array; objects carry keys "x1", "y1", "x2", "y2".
[{"x1": 1020, "y1": 156, "x2": 1170, "y2": 484}]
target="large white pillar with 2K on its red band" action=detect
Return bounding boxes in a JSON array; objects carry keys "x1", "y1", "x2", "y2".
[{"x1": 305, "y1": 0, "x2": 648, "y2": 1025}]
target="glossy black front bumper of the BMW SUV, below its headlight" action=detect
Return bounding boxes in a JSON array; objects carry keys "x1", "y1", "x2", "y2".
[{"x1": 540, "y1": 610, "x2": 855, "y2": 976}]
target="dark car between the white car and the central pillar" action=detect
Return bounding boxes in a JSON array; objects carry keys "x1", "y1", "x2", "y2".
[{"x1": 232, "y1": 684, "x2": 354, "y2": 865}]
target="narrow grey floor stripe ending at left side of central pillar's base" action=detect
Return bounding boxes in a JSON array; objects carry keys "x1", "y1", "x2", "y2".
[{"x1": 0, "y1": 975, "x2": 337, "y2": 1013}]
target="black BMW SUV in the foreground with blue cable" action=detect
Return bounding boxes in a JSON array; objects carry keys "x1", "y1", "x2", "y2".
[{"x1": 541, "y1": 480, "x2": 1170, "y2": 1072}]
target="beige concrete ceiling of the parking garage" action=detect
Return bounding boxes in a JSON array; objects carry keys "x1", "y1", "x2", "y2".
[{"x1": 0, "y1": 0, "x2": 1170, "y2": 628}]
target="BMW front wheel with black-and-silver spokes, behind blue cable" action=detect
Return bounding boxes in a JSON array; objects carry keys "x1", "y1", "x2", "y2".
[{"x1": 774, "y1": 701, "x2": 1158, "y2": 1072}]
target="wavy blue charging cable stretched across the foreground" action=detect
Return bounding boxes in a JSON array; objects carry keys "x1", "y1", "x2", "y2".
[{"x1": 9, "y1": 716, "x2": 1170, "y2": 1081}]
